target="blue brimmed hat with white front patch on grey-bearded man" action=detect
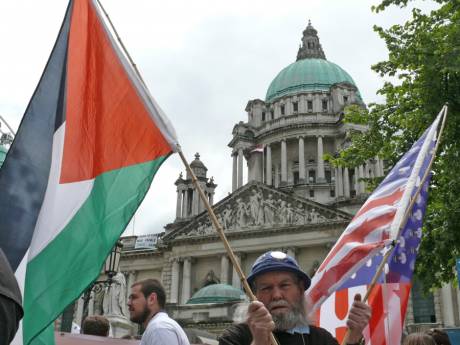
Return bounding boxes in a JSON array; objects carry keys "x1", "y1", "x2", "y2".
[{"x1": 247, "y1": 251, "x2": 310, "y2": 290}]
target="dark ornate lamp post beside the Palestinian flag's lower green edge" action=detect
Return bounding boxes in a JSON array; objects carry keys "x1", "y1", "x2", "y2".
[{"x1": 82, "y1": 240, "x2": 123, "y2": 323}]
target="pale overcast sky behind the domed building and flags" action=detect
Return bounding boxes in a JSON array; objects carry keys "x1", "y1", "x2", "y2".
[{"x1": 0, "y1": 0, "x2": 434, "y2": 234}]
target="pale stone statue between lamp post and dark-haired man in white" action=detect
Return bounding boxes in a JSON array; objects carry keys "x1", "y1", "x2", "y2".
[{"x1": 102, "y1": 272, "x2": 128, "y2": 317}]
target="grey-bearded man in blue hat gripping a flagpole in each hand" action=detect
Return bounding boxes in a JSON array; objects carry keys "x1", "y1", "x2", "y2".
[{"x1": 219, "y1": 251, "x2": 371, "y2": 345}]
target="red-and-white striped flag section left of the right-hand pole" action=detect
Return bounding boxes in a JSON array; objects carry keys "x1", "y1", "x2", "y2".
[{"x1": 306, "y1": 108, "x2": 444, "y2": 312}]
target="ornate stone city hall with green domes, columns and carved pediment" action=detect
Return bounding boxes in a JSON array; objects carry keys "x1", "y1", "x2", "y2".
[{"x1": 66, "y1": 23, "x2": 460, "y2": 333}]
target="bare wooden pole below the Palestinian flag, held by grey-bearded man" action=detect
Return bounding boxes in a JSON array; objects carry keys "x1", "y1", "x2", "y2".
[{"x1": 177, "y1": 145, "x2": 278, "y2": 345}]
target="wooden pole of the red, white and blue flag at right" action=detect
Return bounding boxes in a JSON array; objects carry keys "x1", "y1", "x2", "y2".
[{"x1": 341, "y1": 104, "x2": 447, "y2": 345}]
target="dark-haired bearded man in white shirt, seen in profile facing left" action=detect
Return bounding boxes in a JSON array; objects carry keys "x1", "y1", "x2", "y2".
[{"x1": 128, "y1": 279, "x2": 190, "y2": 345}]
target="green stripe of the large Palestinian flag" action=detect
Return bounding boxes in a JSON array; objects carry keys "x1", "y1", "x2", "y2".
[{"x1": 23, "y1": 156, "x2": 168, "y2": 344}]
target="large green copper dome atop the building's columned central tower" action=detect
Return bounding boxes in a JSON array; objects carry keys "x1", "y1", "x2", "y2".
[{"x1": 265, "y1": 58, "x2": 361, "y2": 102}]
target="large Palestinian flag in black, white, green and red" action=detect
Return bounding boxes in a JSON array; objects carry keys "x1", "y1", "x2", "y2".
[{"x1": 0, "y1": 0, "x2": 177, "y2": 345}]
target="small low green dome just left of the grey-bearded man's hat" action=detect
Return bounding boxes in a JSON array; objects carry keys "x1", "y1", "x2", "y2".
[{"x1": 187, "y1": 284, "x2": 246, "y2": 304}]
